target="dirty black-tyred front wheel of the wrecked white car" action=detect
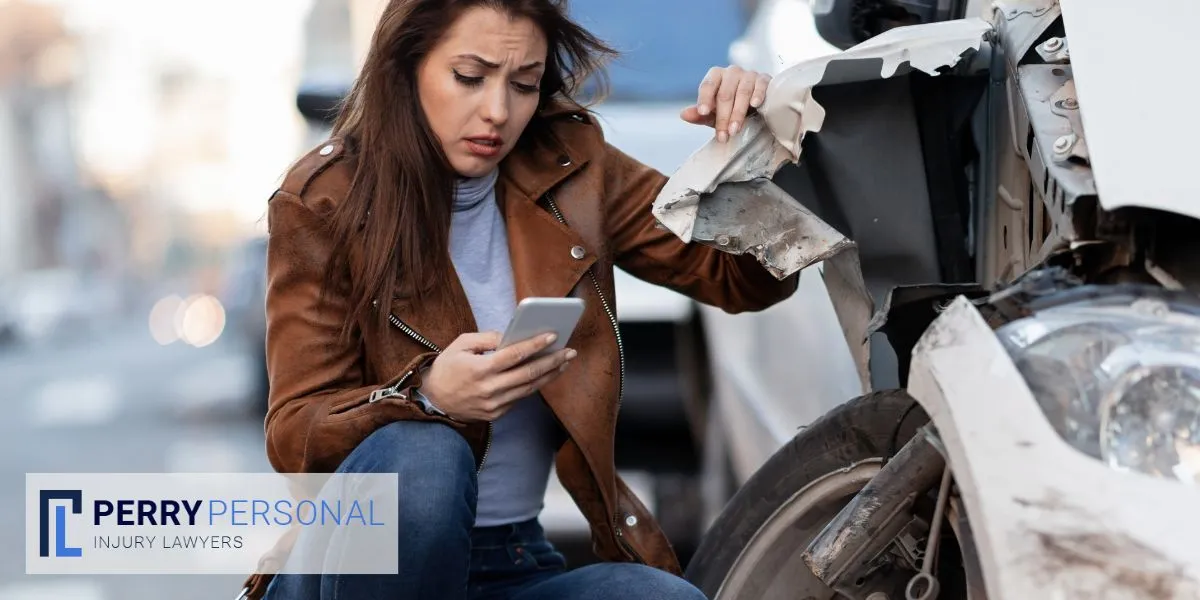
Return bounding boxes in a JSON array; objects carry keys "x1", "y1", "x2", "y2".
[{"x1": 686, "y1": 390, "x2": 982, "y2": 600}]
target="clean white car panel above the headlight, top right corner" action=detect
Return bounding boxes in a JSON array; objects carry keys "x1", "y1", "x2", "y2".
[{"x1": 1061, "y1": 0, "x2": 1200, "y2": 223}]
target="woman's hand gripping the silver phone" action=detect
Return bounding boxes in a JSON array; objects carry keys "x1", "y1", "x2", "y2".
[{"x1": 421, "y1": 332, "x2": 576, "y2": 422}]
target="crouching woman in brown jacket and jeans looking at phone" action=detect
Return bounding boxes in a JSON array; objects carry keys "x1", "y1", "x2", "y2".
[{"x1": 243, "y1": 0, "x2": 797, "y2": 600}]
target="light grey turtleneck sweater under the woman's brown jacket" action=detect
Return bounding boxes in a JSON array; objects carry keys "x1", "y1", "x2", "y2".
[{"x1": 448, "y1": 170, "x2": 556, "y2": 527}]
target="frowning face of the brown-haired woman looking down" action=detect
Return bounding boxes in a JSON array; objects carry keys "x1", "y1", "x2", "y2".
[{"x1": 416, "y1": 7, "x2": 547, "y2": 178}]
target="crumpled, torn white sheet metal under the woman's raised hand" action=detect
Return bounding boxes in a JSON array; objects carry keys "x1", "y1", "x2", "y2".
[{"x1": 652, "y1": 18, "x2": 991, "y2": 278}]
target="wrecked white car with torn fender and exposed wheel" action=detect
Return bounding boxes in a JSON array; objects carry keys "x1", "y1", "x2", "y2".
[{"x1": 667, "y1": 0, "x2": 1200, "y2": 600}]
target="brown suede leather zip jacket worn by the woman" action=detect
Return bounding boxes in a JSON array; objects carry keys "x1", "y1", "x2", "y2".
[{"x1": 236, "y1": 106, "x2": 797, "y2": 598}]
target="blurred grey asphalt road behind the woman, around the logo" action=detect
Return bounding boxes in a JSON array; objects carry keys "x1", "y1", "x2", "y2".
[{"x1": 0, "y1": 320, "x2": 619, "y2": 600}]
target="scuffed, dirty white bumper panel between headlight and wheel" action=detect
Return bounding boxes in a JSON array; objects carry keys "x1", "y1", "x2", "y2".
[{"x1": 908, "y1": 298, "x2": 1200, "y2": 600}]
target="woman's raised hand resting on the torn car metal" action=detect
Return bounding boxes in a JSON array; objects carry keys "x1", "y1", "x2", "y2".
[{"x1": 679, "y1": 66, "x2": 770, "y2": 143}]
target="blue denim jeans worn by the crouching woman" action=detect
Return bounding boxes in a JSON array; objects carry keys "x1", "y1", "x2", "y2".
[{"x1": 265, "y1": 421, "x2": 704, "y2": 600}]
